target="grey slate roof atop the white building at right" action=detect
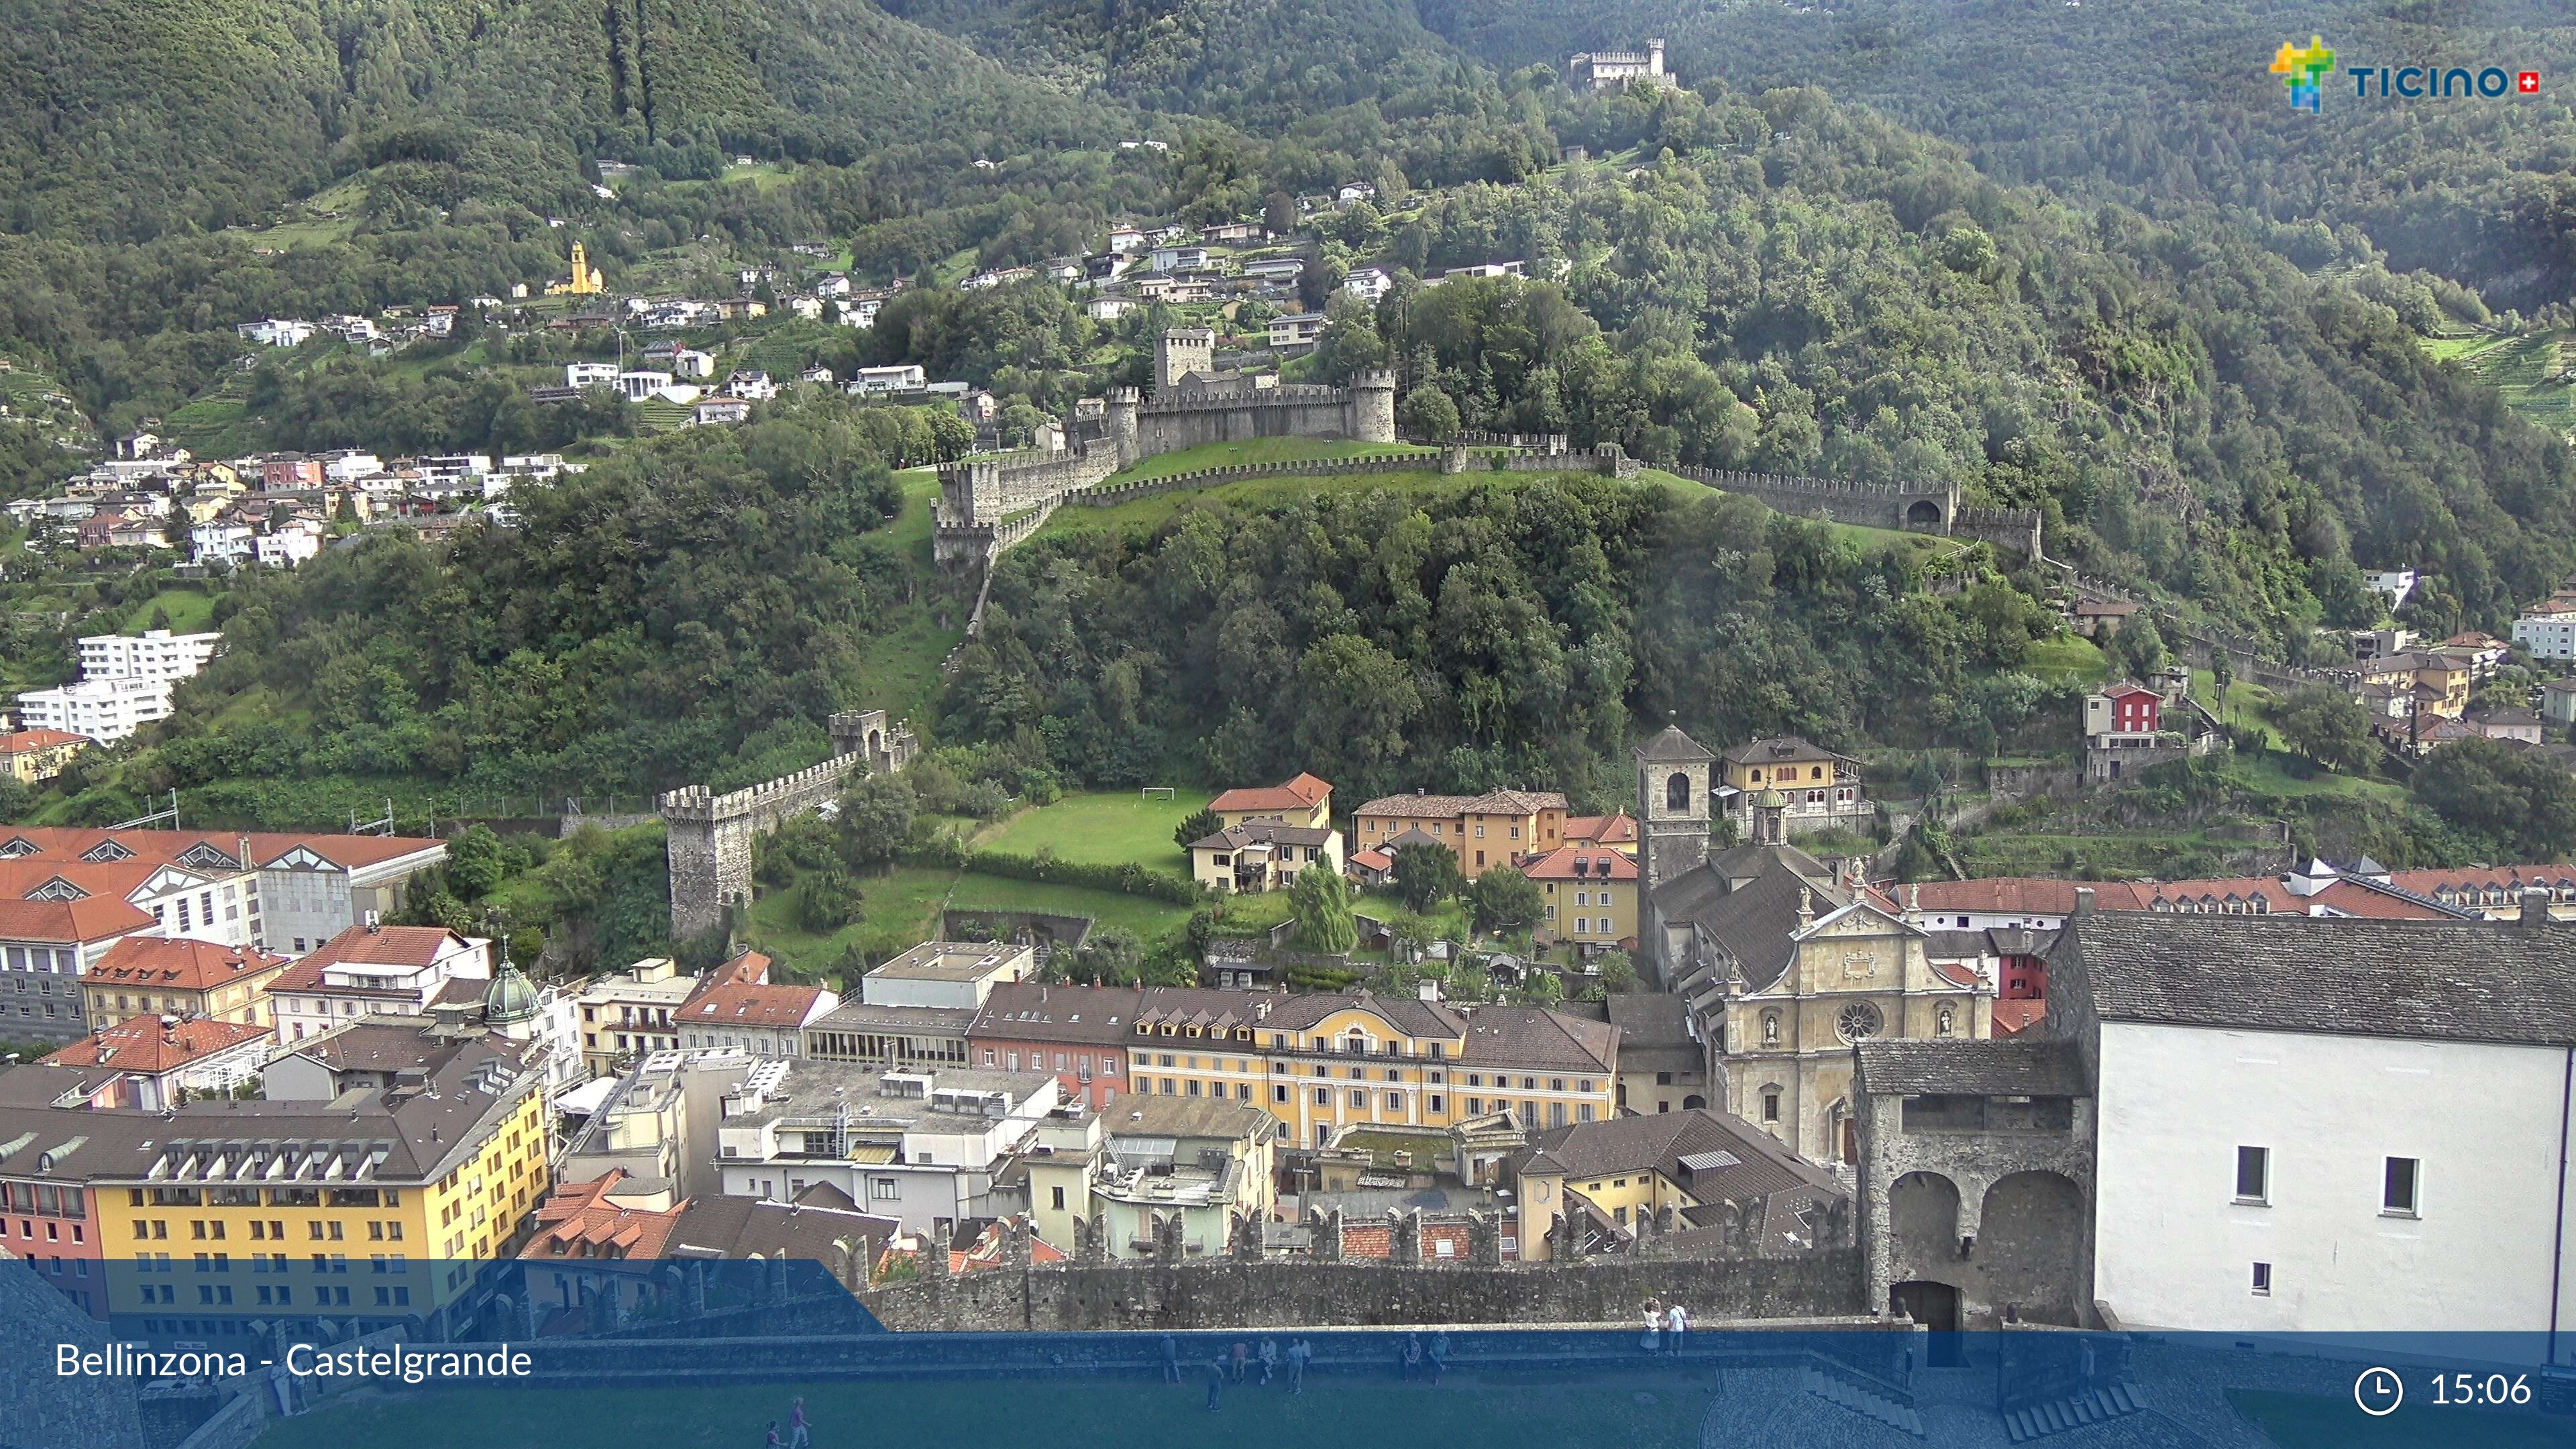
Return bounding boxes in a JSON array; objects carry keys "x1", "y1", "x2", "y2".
[{"x1": 2051, "y1": 910, "x2": 2576, "y2": 1046}]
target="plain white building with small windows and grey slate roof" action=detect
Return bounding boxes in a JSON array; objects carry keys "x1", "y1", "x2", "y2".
[{"x1": 2048, "y1": 892, "x2": 2576, "y2": 1361}]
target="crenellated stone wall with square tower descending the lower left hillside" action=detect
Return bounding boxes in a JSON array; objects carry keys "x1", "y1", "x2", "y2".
[{"x1": 654, "y1": 709, "x2": 914, "y2": 941}]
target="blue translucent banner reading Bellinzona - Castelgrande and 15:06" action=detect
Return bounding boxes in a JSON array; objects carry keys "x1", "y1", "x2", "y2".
[{"x1": 0, "y1": 1258, "x2": 2576, "y2": 1449}]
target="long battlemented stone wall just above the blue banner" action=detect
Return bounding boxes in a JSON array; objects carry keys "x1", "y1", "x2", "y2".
[{"x1": 863, "y1": 1248, "x2": 1862, "y2": 1330}]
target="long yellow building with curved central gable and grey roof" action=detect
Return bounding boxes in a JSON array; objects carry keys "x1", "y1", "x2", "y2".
[{"x1": 1128, "y1": 987, "x2": 1618, "y2": 1147}]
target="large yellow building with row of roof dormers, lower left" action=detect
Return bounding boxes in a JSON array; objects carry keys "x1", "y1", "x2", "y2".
[{"x1": 85, "y1": 1042, "x2": 551, "y2": 1326}]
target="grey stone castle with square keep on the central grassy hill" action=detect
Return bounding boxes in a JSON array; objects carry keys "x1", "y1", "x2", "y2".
[{"x1": 935, "y1": 327, "x2": 1396, "y2": 565}]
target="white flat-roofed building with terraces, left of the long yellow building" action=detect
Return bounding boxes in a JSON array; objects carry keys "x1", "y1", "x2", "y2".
[{"x1": 716, "y1": 1060, "x2": 1064, "y2": 1232}]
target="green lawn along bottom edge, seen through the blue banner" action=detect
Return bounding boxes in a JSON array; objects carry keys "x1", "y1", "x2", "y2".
[{"x1": 258, "y1": 1372, "x2": 1711, "y2": 1449}]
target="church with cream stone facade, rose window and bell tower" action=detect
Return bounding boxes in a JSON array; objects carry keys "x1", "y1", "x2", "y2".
[{"x1": 1635, "y1": 727, "x2": 1994, "y2": 1163}]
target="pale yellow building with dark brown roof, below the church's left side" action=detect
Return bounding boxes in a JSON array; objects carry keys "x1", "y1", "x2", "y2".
[{"x1": 1507, "y1": 1106, "x2": 1849, "y2": 1263}]
